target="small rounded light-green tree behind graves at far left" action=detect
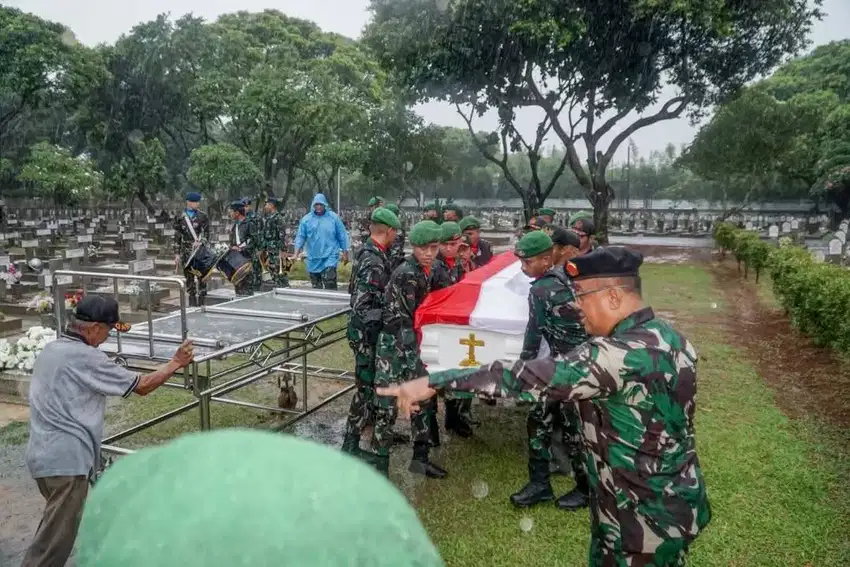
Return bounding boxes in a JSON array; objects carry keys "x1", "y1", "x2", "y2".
[{"x1": 19, "y1": 142, "x2": 103, "y2": 206}]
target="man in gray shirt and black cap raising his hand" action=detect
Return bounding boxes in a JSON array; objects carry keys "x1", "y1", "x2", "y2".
[{"x1": 21, "y1": 295, "x2": 193, "y2": 567}]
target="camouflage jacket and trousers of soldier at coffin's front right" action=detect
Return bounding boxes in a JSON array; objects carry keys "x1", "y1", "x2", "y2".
[{"x1": 520, "y1": 266, "x2": 589, "y2": 504}]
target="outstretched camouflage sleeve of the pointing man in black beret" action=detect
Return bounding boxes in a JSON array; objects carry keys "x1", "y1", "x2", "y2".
[{"x1": 429, "y1": 337, "x2": 629, "y2": 401}]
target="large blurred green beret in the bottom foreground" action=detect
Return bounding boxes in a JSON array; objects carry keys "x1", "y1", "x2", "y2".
[{"x1": 75, "y1": 429, "x2": 444, "y2": 567}]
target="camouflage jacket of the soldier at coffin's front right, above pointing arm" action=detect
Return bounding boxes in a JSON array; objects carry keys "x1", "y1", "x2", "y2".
[{"x1": 519, "y1": 266, "x2": 589, "y2": 360}]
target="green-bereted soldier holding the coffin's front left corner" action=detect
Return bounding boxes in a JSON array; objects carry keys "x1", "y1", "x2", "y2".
[{"x1": 372, "y1": 221, "x2": 447, "y2": 478}]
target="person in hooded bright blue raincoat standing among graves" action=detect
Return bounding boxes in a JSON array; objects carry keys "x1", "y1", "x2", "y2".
[{"x1": 295, "y1": 193, "x2": 349, "y2": 289}]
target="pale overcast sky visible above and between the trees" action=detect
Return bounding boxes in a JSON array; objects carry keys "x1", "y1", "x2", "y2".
[{"x1": 4, "y1": 0, "x2": 850, "y2": 164}]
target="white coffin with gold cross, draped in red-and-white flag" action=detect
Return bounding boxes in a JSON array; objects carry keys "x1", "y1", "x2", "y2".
[{"x1": 415, "y1": 252, "x2": 548, "y2": 372}]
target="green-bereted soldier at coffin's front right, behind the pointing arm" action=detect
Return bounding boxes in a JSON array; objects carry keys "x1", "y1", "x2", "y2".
[{"x1": 511, "y1": 227, "x2": 589, "y2": 510}]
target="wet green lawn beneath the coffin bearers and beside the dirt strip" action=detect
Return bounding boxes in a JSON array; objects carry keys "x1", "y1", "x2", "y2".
[{"x1": 416, "y1": 264, "x2": 850, "y2": 567}]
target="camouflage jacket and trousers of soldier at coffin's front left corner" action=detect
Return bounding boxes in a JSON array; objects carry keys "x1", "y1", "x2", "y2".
[{"x1": 372, "y1": 256, "x2": 435, "y2": 459}]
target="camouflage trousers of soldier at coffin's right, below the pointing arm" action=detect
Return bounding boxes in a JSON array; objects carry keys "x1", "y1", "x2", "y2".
[{"x1": 526, "y1": 402, "x2": 586, "y2": 481}]
